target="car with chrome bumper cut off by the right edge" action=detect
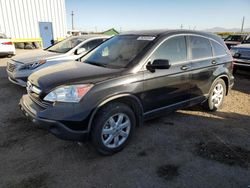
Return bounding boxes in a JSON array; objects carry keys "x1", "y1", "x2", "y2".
[{"x1": 230, "y1": 37, "x2": 250, "y2": 73}]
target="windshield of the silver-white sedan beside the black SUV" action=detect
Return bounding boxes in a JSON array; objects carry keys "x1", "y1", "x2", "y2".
[{"x1": 46, "y1": 37, "x2": 85, "y2": 53}]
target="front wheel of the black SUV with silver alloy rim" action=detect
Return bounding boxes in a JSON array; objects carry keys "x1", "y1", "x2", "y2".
[{"x1": 91, "y1": 102, "x2": 136, "y2": 155}]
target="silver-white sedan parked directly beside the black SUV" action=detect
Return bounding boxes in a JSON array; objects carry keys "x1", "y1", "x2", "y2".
[{"x1": 6, "y1": 35, "x2": 109, "y2": 87}]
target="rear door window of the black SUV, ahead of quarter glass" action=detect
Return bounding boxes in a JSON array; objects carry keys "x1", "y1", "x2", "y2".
[{"x1": 190, "y1": 36, "x2": 213, "y2": 59}]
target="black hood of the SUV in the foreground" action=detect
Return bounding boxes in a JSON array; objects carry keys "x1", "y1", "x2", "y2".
[{"x1": 28, "y1": 61, "x2": 122, "y2": 93}]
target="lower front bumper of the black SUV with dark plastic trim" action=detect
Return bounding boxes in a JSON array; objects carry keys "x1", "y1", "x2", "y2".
[{"x1": 19, "y1": 95, "x2": 89, "y2": 141}]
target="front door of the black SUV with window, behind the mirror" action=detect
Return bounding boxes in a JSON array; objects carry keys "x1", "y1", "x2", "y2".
[{"x1": 143, "y1": 36, "x2": 191, "y2": 113}]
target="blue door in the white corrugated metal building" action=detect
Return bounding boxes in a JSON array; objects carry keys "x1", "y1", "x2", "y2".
[{"x1": 39, "y1": 22, "x2": 53, "y2": 48}]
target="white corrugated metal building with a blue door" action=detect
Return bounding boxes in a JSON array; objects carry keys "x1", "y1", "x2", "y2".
[{"x1": 0, "y1": 0, "x2": 67, "y2": 48}]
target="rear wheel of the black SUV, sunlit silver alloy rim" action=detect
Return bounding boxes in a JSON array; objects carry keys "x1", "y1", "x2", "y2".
[{"x1": 203, "y1": 78, "x2": 226, "y2": 111}]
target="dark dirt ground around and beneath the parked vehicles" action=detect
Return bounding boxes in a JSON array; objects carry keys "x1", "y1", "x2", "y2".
[{"x1": 0, "y1": 52, "x2": 250, "y2": 188}]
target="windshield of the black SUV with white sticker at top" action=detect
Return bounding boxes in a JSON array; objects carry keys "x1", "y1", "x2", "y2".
[{"x1": 83, "y1": 35, "x2": 152, "y2": 68}]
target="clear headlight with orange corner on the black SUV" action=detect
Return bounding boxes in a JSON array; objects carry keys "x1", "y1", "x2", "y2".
[{"x1": 44, "y1": 84, "x2": 93, "y2": 103}]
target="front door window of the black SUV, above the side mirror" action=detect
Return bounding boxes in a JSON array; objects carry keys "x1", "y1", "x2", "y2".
[{"x1": 151, "y1": 36, "x2": 187, "y2": 63}]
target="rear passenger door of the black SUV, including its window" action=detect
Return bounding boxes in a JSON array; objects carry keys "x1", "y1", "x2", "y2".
[{"x1": 188, "y1": 36, "x2": 217, "y2": 100}]
